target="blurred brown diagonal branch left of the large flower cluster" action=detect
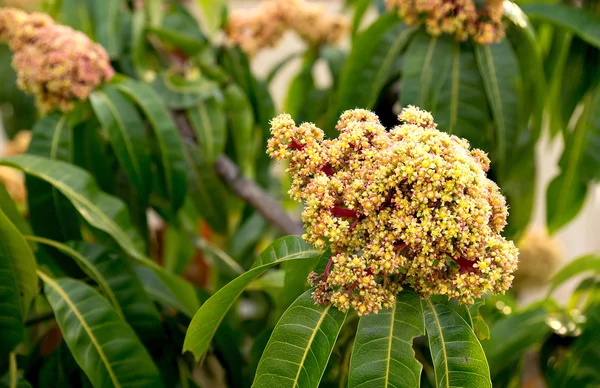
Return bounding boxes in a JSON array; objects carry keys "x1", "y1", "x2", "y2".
[{"x1": 171, "y1": 111, "x2": 303, "y2": 235}]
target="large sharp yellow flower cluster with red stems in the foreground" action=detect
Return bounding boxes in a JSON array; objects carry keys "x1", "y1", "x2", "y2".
[{"x1": 268, "y1": 106, "x2": 518, "y2": 315}]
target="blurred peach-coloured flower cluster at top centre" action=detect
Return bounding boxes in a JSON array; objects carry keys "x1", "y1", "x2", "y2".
[{"x1": 227, "y1": 0, "x2": 348, "y2": 55}]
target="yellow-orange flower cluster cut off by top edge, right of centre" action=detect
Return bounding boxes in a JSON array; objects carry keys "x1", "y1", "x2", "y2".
[{"x1": 386, "y1": 0, "x2": 504, "y2": 44}]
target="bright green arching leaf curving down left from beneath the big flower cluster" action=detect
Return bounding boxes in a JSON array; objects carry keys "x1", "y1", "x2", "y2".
[{"x1": 183, "y1": 236, "x2": 321, "y2": 360}]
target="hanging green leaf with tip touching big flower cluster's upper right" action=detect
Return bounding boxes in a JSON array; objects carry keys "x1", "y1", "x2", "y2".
[{"x1": 475, "y1": 40, "x2": 527, "y2": 179}]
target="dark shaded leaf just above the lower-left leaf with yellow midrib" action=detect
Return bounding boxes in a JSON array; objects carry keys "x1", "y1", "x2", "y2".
[{"x1": 71, "y1": 242, "x2": 162, "y2": 342}]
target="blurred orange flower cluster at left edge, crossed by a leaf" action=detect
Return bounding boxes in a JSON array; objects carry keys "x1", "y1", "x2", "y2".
[{"x1": 0, "y1": 131, "x2": 31, "y2": 204}]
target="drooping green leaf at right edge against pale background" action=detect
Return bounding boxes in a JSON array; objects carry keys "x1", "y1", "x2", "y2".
[{"x1": 546, "y1": 91, "x2": 600, "y2": 233}]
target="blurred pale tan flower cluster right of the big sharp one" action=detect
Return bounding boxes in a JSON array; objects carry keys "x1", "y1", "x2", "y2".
[{"x1": 513, "y1": 229, "x2": 563, "y2": 291}]
